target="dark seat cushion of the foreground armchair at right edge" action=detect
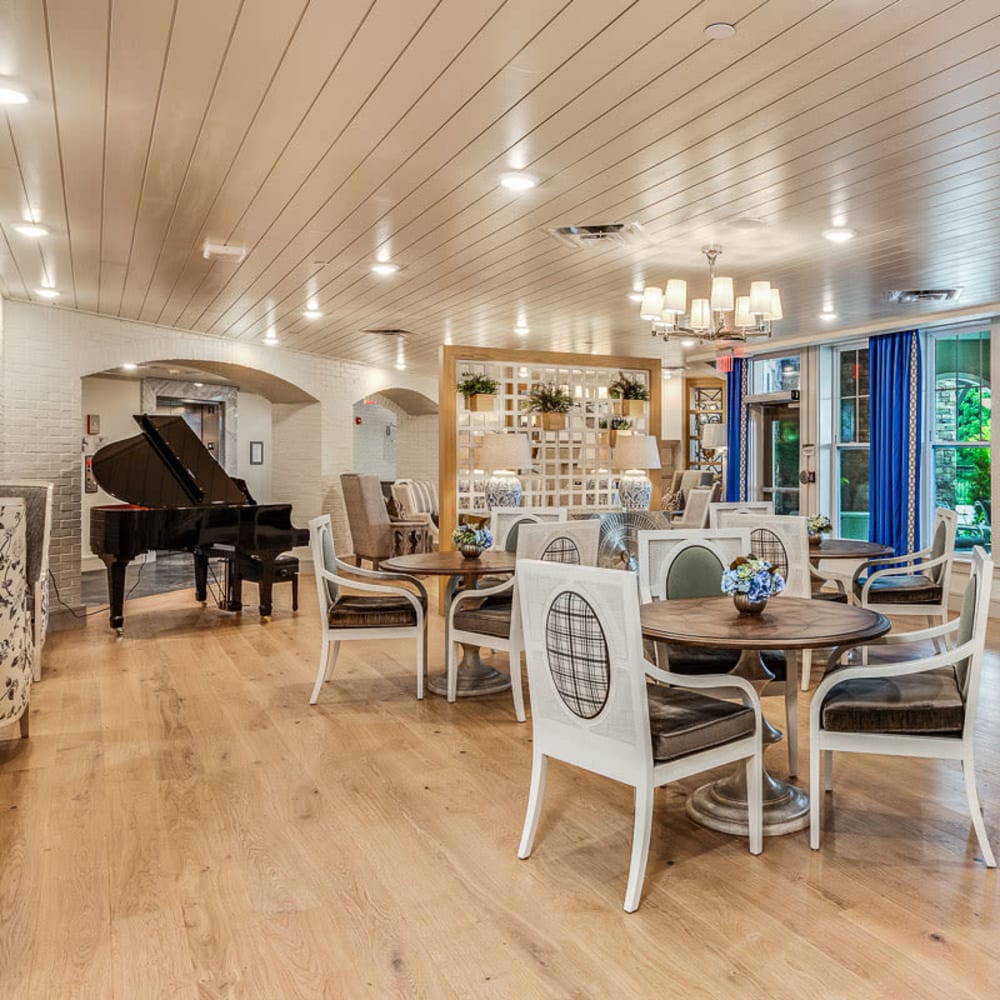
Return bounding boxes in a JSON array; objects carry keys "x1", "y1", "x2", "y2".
[{"x1": 820, "y1": 667, "x2": 965, "y2": 736}]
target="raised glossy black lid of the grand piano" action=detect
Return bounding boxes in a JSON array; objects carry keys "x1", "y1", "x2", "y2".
[{"x1": 91, "y1": 413, "x2": 247, "y2": 507}]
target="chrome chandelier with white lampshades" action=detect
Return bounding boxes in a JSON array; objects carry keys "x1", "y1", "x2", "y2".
[{"x1": 639, "y1": 243, "x2": 782, "y2": 341}]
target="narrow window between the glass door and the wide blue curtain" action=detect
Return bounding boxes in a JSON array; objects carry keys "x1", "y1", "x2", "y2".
[{"x1": 836, "y1": 347, "x2": 871, "y2": 539}]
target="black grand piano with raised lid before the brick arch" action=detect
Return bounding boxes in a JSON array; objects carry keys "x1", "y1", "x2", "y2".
[{"x1": 90, "y1": 414, "x2": 309, "y2": 633}]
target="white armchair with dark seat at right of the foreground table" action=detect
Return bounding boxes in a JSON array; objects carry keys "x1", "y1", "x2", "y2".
[{"x1": 809, "y1": 546, "x2": 996, "y2": 868}]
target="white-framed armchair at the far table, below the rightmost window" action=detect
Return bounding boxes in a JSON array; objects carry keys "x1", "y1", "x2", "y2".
[{"x1": 852, "y1": 507, "x2": 958, "y2": 625}]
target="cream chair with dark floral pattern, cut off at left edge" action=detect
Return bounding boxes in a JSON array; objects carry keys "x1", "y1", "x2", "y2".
[{"x1": 0, "y1": 496, "x2": 32, "y2": 737}]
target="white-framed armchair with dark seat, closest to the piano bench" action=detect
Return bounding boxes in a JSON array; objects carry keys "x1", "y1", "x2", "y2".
[{"x1": 309, "y1": 514, "x2": 427, "y2": 705}]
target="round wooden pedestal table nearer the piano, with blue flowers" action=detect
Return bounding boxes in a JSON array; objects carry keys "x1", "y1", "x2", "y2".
[{"x1": 379, "y1": 549, "x2": 514, "y2": 698}]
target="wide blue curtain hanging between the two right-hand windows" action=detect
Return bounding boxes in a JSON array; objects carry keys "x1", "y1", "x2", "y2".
[{"x1": 868, "y1": 330, "x2": 922, "y2": 555}]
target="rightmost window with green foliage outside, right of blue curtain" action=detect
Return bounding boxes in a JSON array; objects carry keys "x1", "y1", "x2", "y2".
[{"x1": 931, "y1": 330, "x2": 992, "y2": 549}]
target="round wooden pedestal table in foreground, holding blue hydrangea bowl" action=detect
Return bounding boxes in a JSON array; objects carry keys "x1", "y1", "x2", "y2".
[{"x1": 639, "y1": 597, "x2": 890, "y2": 836}]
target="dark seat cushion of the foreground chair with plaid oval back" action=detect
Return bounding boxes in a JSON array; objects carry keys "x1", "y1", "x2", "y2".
[{"x1": 646, "y1": 685, "x2": 754, "y2": 763}]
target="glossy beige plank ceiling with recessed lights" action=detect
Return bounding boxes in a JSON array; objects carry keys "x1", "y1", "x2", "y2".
[{"x1": 0, "y1": 0, "x2": 1000, "y2": 371}]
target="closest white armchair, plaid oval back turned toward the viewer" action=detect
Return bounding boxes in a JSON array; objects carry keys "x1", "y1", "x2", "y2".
[{"x1": 517, "y1": 560, "x2": 763, "y2": 913}]
